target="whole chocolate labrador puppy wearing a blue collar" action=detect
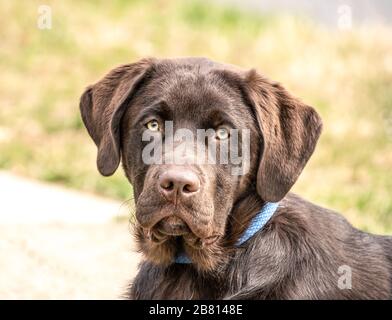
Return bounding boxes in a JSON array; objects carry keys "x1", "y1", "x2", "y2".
[{"x1": 80, "y1": 58, "x2": 392, "y2": 299}]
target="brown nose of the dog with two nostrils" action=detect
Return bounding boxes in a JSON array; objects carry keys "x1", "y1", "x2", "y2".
[{"x1": 158, "y1": 168, "x2": 200, "y2": 202}]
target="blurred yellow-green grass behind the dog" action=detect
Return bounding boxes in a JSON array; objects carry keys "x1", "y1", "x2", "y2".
[{"x1": 0, "y1": 0, "x2": 392, "y2": 233}]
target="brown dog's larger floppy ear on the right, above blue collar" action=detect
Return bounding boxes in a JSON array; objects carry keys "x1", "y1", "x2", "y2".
[{"x1": 245, "y1": 70, "x2": 322, "y2": 202}]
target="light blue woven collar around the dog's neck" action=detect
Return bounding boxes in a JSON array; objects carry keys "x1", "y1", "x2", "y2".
[{"x1": 175, "y1": 202, "x2": 279, "y2": 264}]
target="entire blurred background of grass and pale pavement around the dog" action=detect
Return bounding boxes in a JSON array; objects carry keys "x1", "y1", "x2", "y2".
[{"x1": 0, "y1": 0, "x2": 392, "y2": 298}]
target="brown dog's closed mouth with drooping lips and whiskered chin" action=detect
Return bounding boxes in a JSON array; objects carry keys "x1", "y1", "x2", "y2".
[{"x1": 136, "y1": 206, "x2": 224, "y2": 270}]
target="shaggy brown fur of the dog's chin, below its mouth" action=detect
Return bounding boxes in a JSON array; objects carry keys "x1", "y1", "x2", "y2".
[{"x1": 135, "y1": 226, "x2": 228, "y2": 272}]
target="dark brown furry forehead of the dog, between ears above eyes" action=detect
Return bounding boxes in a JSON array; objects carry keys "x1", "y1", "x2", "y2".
[{"x1": 125, "y1": 58, "x2": 249, "y2": 125}]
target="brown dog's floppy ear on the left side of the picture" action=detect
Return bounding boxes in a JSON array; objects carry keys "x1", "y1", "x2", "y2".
[{"x1": 80, "y1": 59, "x2": 152, "y2": 176}]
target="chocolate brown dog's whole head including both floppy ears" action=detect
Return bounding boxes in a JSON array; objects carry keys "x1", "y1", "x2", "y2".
[{"x1": 80, "y1": 58, "x2": 321, "y2": 270}]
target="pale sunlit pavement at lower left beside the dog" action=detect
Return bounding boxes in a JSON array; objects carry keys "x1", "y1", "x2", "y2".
[{"x1": 0, "y1": 172, "x2": 140, "y2": 299}]
